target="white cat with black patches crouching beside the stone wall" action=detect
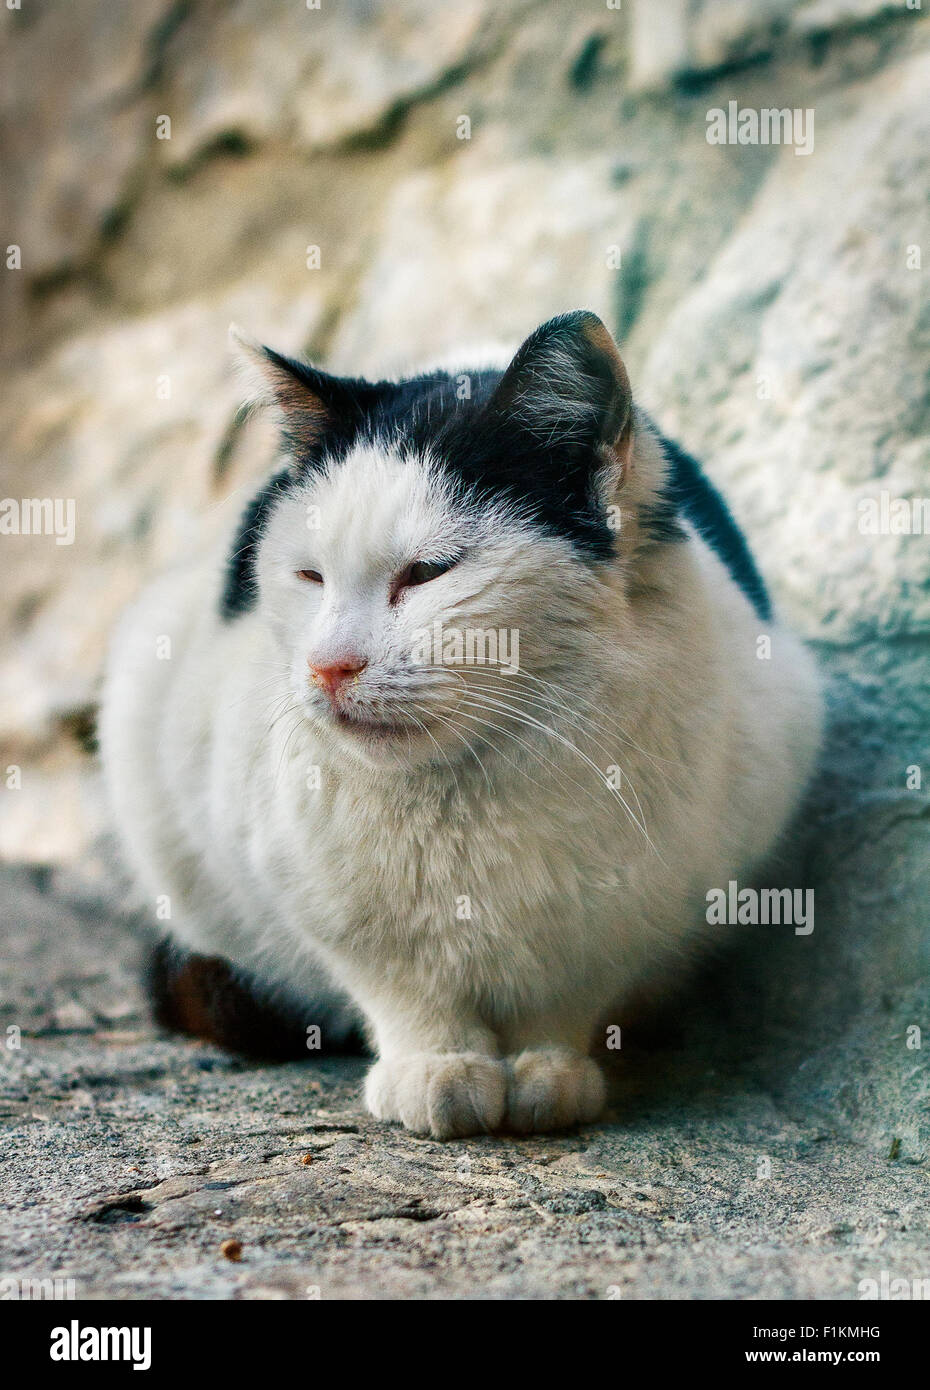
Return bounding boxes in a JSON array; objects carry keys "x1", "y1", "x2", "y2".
[{"x1": 100, "y1": 310, "x2": 822, "y2": 1138}]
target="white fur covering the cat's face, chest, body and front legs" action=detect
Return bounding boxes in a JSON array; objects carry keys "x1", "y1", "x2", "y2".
[{"x1": 101, "y1": 394, "x2": 820, "y2": 1137}]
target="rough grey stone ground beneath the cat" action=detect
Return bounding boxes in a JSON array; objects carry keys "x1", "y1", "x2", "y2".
[{"x1": 0, "y1": 795, "x2": 930, "y2": 1300}]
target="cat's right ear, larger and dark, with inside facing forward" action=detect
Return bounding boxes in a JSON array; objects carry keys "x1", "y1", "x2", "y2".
[{"x1": 491, "y1": 309, "x2": 633, "y2": 467}]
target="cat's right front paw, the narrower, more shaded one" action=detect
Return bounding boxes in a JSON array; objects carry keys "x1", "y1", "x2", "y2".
[{"x1": 507, "y1": 1047, "x2": 606, "y2": 1134}]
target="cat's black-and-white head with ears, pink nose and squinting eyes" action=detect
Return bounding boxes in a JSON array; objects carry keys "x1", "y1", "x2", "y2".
[{"x1": 233, "y1": 311, "x2": 667, "y2": 763}]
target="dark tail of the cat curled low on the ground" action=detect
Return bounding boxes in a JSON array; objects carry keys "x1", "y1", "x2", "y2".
[{"x1": 147, "y1": 940, "x2": 366, "y2": 1062}]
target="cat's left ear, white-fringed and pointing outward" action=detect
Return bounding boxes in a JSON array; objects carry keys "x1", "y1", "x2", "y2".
[{"x1": 229, "y1": 324, "x2": 349, "y2": 450}]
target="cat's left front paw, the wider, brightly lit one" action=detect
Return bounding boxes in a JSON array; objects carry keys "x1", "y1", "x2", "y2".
[{"x1": 364, "y1": 1052, "x2": 507, "y2": 1138}]
